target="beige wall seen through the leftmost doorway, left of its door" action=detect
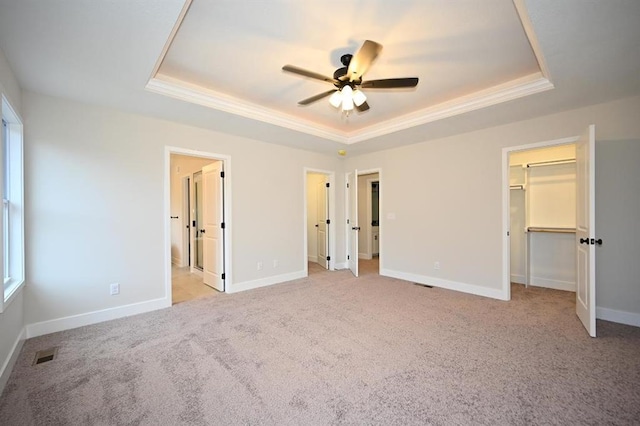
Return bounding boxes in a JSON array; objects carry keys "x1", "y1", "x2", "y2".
[{"x1": 170, "y1": 154, "x2": 215, "y2": 267}]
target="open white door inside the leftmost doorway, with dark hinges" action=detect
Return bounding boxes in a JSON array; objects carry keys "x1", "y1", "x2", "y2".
[{"x1": 202, "y1": 161, "x2": 224, "y2": 291}]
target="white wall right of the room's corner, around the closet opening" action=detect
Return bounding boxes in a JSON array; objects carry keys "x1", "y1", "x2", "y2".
[{"x1": 346, "y1": 97, "x2": 640, "y2": 314}]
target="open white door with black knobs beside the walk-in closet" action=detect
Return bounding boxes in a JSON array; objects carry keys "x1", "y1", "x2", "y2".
[{"x1": 576, "y1": 125, "x2": 596, "y2": 337}]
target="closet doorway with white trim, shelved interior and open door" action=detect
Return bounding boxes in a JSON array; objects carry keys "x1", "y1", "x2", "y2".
[{"x1": 502, "y1": 125, "x2": 602, "y2": 337}]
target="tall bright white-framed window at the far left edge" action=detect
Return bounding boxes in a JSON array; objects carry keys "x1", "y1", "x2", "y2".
[{"x1": 0, "y1": 96, "x2": 24, "y2": 312}]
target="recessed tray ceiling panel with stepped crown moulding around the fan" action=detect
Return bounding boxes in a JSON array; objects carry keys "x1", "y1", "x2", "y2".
[{"x1": 152, "y1": 0, "x2": 550, "y2": 142}]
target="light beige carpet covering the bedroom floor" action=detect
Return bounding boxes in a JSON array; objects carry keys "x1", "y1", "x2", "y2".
[{"x1": 0, "y1": 264, "x2": 640, "y2": 425}]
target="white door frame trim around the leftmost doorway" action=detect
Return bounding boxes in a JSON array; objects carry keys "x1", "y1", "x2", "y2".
[{"x1": 163, "y1": 145, "x2": 233, "y2": 306}]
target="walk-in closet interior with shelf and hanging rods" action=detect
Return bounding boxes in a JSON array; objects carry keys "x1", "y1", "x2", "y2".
[{"x1": 509, "y1": 144, "x2": 576, "y2": 291}]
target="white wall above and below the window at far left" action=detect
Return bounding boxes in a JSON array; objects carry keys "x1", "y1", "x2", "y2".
[{"x1": 0, "y1": 45, "x2": 25, "y2": 394}]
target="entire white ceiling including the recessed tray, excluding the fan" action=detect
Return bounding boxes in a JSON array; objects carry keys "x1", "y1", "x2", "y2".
[{"x1": 0, "y1": 0, "x2": 640, "y2": 153}]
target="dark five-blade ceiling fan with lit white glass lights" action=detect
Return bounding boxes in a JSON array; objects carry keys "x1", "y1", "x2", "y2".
[{"x1": 282, "y1": 40, "x2": 418, "y2": 114}]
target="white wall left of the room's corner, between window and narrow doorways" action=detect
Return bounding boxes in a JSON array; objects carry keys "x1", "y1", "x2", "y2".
[{"x1": 23, "y1": 92, "x2": 345, "y2": 334}]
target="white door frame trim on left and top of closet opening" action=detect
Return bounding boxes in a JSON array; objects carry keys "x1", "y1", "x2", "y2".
[{"x1": 500, "y1": 136, "x2": 579, "y2": 300}]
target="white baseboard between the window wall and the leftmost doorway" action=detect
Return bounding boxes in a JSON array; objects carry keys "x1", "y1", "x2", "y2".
[{"x1": 26, "y1": 297, "x2": 171, "y2": 338}]
